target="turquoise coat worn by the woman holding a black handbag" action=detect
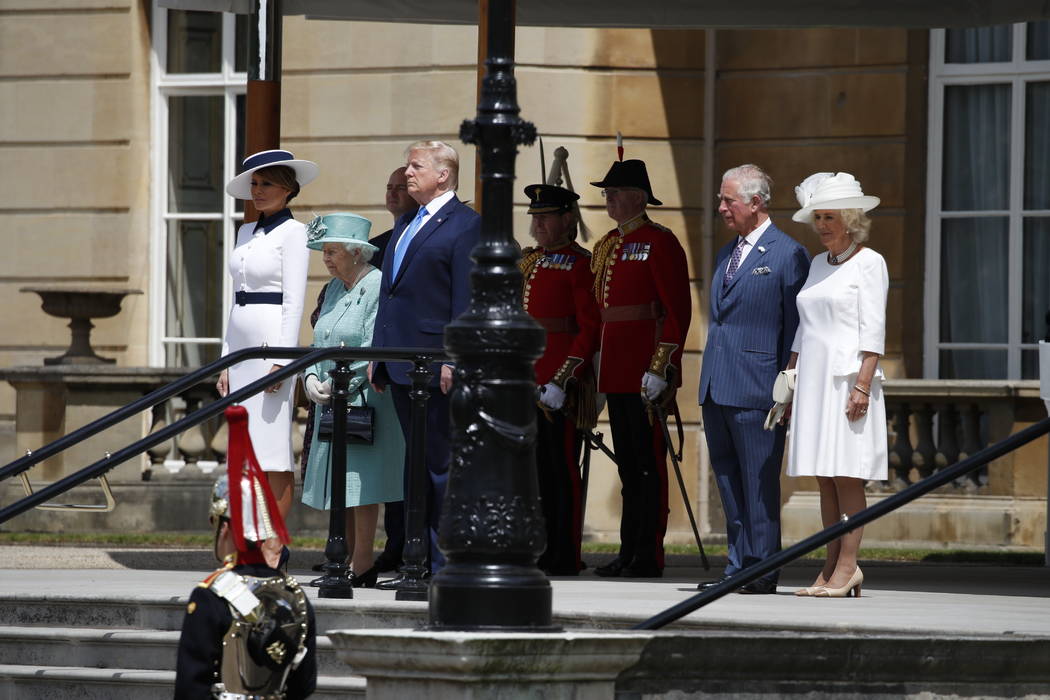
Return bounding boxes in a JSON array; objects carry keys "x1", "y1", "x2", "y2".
[{"x1": 302, "y1": 269, "x2": 404, "y2": 510}]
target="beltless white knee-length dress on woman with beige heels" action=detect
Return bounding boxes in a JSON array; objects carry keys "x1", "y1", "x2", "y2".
[{"x1": 788, "y1": 248, "x2": 889, "y2": 480}]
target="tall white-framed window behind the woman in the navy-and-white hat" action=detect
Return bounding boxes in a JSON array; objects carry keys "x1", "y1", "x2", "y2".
[{"x1": 150, "y1": 7, "x2": 248, "y2": 366}]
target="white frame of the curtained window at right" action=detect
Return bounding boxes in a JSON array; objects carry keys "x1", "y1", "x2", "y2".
[{"x1": 923, "y1": 22, "x2": 1050, "y2": 380}]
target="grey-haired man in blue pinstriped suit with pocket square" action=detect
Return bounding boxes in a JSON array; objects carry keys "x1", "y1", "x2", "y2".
[{"x1": 699, "y1": 165, "x2": 810, "y2": 593}]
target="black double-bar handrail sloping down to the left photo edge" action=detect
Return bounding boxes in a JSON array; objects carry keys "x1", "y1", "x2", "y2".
[{"x1": 0, "y1": 347, "x2": 447, "y2": 524}]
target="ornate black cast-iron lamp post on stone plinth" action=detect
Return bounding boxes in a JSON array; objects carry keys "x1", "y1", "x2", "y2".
[{"x1": 429, "y1": 0, "x2": 551, "y2": 630}]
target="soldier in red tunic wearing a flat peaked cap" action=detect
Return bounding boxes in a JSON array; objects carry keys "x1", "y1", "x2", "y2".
[{"x1": 519, "y1": 185, "x2": 600, "y2": 576}]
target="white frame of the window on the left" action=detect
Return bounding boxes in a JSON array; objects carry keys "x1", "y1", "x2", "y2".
[{"x1": 148, "y1": 5, "x2": 248, "y2": 366}]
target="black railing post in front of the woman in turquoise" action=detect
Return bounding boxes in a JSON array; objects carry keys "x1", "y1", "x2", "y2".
[{"x1": 317, "y1": 360, "x2": 354, "y2": 598}]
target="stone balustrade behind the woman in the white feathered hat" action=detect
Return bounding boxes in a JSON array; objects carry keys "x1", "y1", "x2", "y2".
[{"x1": 781, "y1": 379, "x2": 1048, "y2": 548}]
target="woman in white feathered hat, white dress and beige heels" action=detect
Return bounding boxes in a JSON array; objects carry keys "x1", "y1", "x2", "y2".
[{"x1": 788, "y1": 172, "x2": 889, "y2": 597}]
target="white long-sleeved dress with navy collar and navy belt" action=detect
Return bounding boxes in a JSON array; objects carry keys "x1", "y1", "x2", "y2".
[{"x1": 223, "y1": 209, "x2": 310, "y2": 471}]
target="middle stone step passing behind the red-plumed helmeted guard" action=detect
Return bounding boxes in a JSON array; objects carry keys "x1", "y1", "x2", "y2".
[{"x1": 0, "y1": 625, "x2": 349, "y2": 676}]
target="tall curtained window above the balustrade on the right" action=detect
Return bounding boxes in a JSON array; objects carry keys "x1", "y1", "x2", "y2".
[{"x1": 925, "y1": 21, "x2": 1050, "y2": 379}]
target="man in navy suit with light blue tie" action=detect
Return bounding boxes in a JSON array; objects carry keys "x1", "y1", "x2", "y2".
[{"x1": 371, "y1": 141, "x2": 481, "y2": 573}]
